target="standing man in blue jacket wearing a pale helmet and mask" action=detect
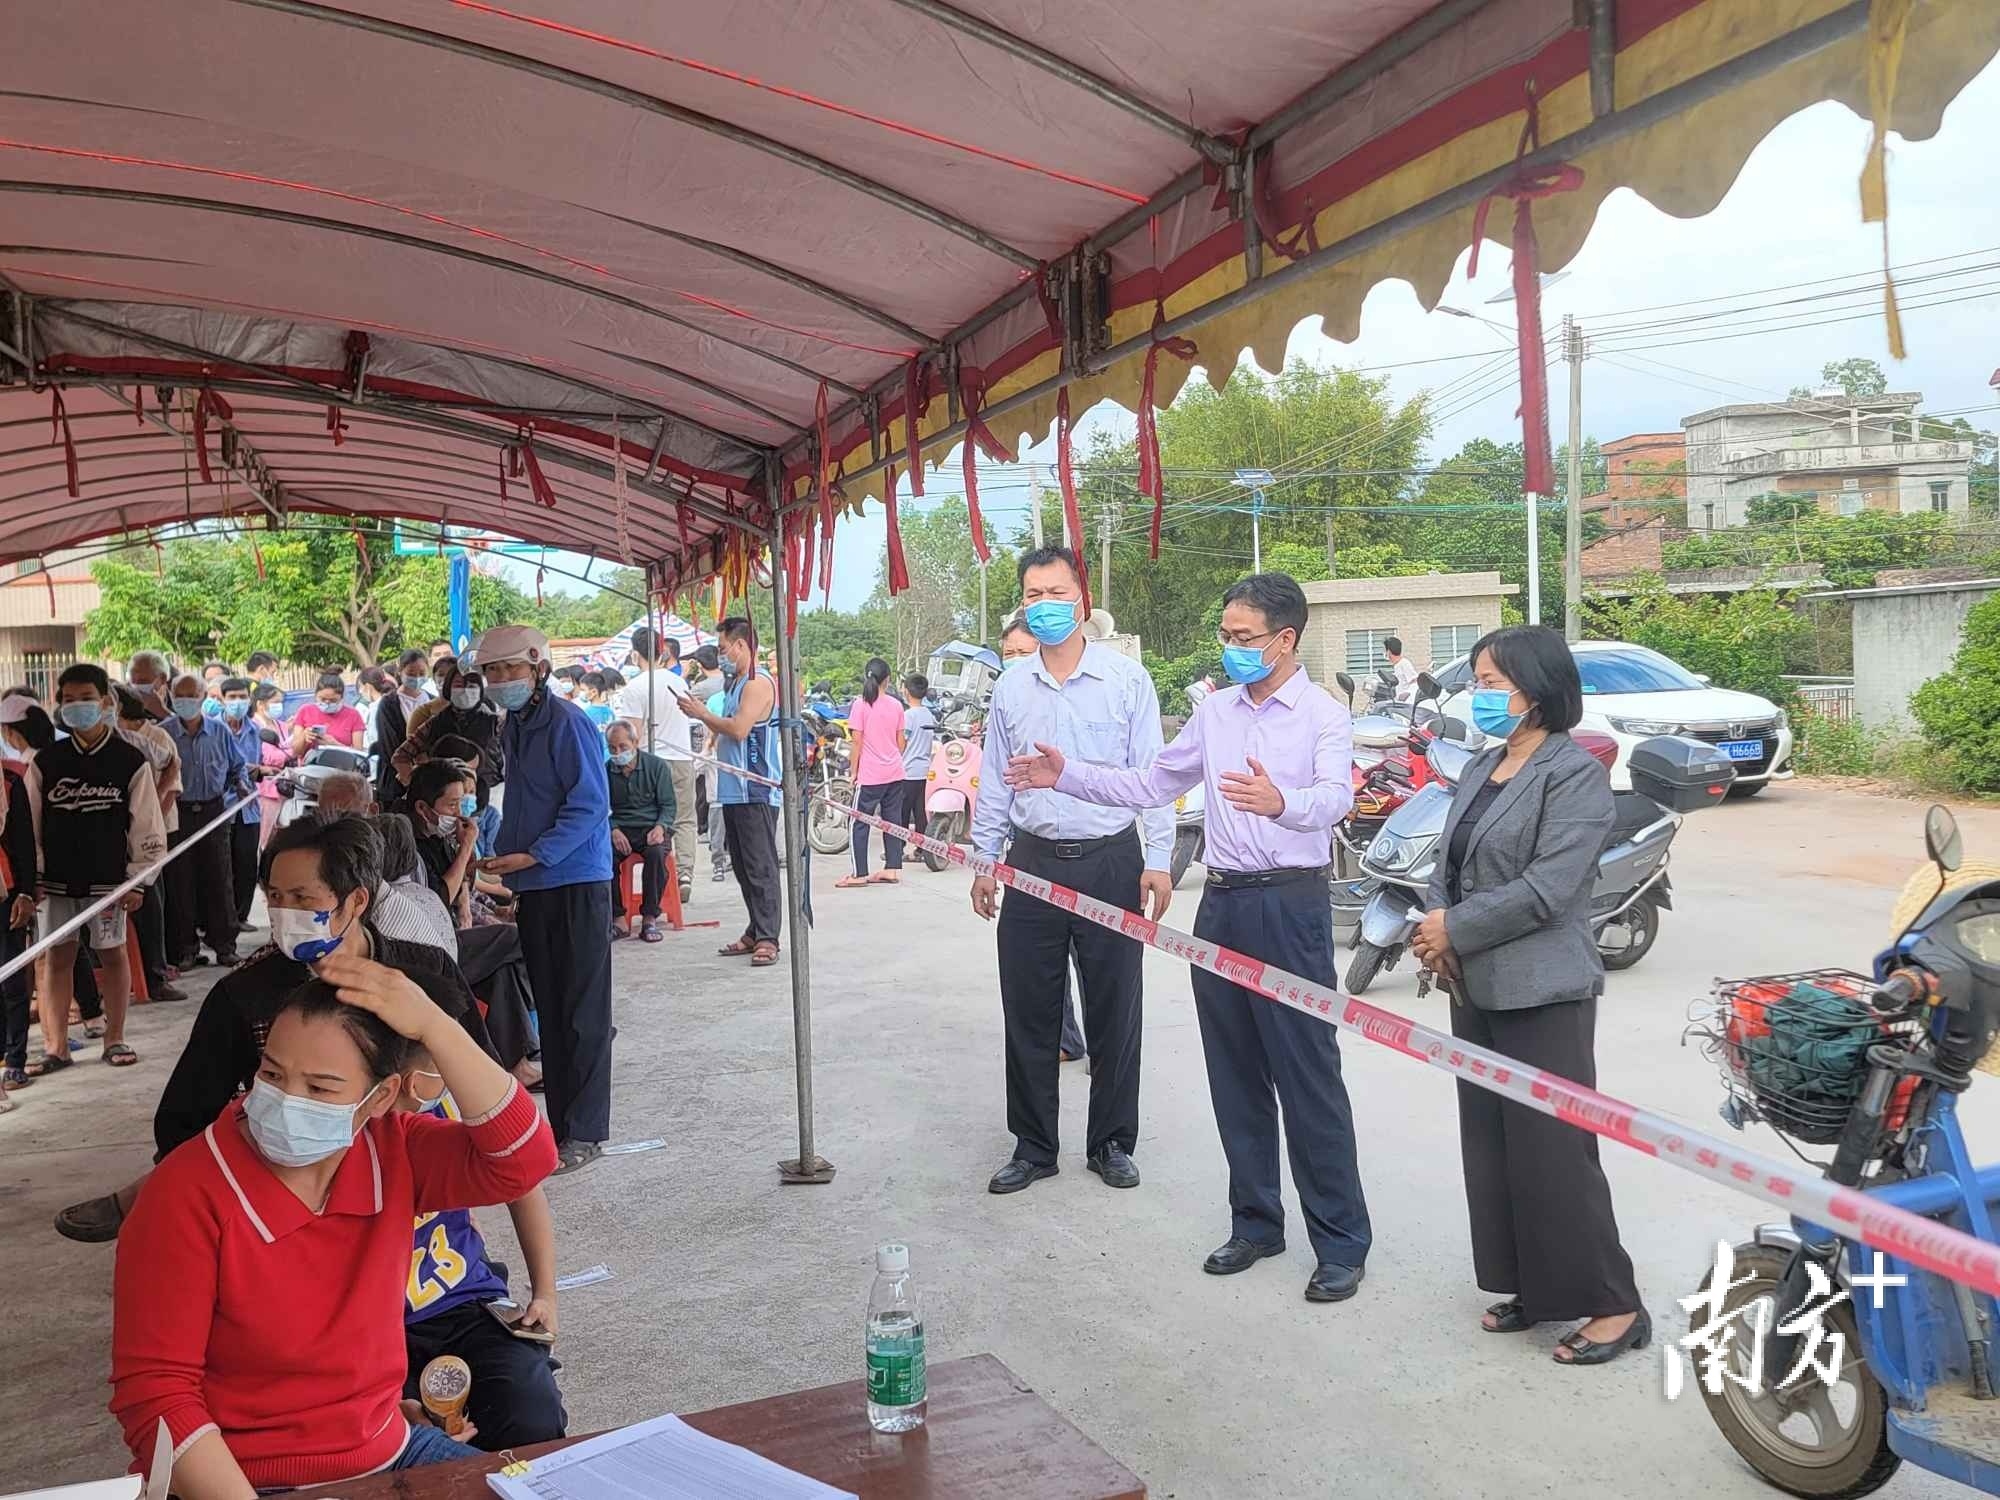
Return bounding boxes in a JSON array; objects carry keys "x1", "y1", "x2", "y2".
[{"x1": 468, "y1": 626, "x2": 612, "y2": 1174}]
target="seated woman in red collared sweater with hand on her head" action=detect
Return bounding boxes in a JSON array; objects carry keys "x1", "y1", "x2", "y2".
[{"x1": 112, "y1": 952, "x2": 556, "y2": 1500}]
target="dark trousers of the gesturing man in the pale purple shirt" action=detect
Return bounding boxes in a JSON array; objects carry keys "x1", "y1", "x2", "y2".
[{"x1": 1184, "y1": 880, "x2": 1372, "y2": 1266}]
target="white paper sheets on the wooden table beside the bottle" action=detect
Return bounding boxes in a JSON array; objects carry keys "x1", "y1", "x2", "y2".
[{"x1": 486, "y1": 1416, "x2": 856, "y2": 1500}]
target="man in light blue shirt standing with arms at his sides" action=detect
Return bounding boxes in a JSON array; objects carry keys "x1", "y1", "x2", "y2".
[{"x1": 972, "y1": 546, "x2": 1174, "y2": 1192}]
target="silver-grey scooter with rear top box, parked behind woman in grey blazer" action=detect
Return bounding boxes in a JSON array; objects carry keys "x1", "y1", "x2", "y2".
[{"x1": 1334, "y1": 720, "x2": 1736, "y2": 994}]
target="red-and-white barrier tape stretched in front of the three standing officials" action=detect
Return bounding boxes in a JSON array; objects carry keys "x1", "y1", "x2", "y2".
[{"x1": 696, "y1": 756, "x2": 2000, "y2": 1296}]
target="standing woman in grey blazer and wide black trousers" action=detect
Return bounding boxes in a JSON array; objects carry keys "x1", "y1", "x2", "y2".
[{"x1": 1412, "y1": 626, "x2": 1652, "y2": 1364}]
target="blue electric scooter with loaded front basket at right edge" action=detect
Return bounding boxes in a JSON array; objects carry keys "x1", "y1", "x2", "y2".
[{"x1": 1688, "y1": 808, "x2": 2000, "y2": 1496}]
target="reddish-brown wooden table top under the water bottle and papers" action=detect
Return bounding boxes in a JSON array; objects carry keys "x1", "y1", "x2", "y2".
[{"x1": 298, "y1": 1354, "x2": 1146, "y2": 1500}]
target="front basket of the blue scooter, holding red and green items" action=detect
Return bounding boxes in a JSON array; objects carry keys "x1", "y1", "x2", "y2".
[{"x1": 1708, "y1": 968, "x2": 1914, "y2": 1146}]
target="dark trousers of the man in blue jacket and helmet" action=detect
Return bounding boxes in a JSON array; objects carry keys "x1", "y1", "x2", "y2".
[{"x1": 508, "y1": 880, "x2": 612, "y2": 1144}]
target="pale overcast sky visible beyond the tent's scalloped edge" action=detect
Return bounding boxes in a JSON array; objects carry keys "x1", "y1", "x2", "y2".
[{"x1": 530, "y1": 50, "x2": 2000, "y2": 608}]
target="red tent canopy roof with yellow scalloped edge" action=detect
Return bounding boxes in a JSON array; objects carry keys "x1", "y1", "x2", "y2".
[{"x1": 0, "y1": 0, "x2": 2000, "y2": 586}]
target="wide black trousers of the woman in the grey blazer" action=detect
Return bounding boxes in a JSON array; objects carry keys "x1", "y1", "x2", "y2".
[{"x1": 1452, "y1": 1000, "x2": 1640, "y2": 1322}]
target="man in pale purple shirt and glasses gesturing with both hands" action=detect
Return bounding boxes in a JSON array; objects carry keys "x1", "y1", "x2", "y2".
[{"x1": 1006, "y1": 572, "x2": 1370, "y2": 1302}]
